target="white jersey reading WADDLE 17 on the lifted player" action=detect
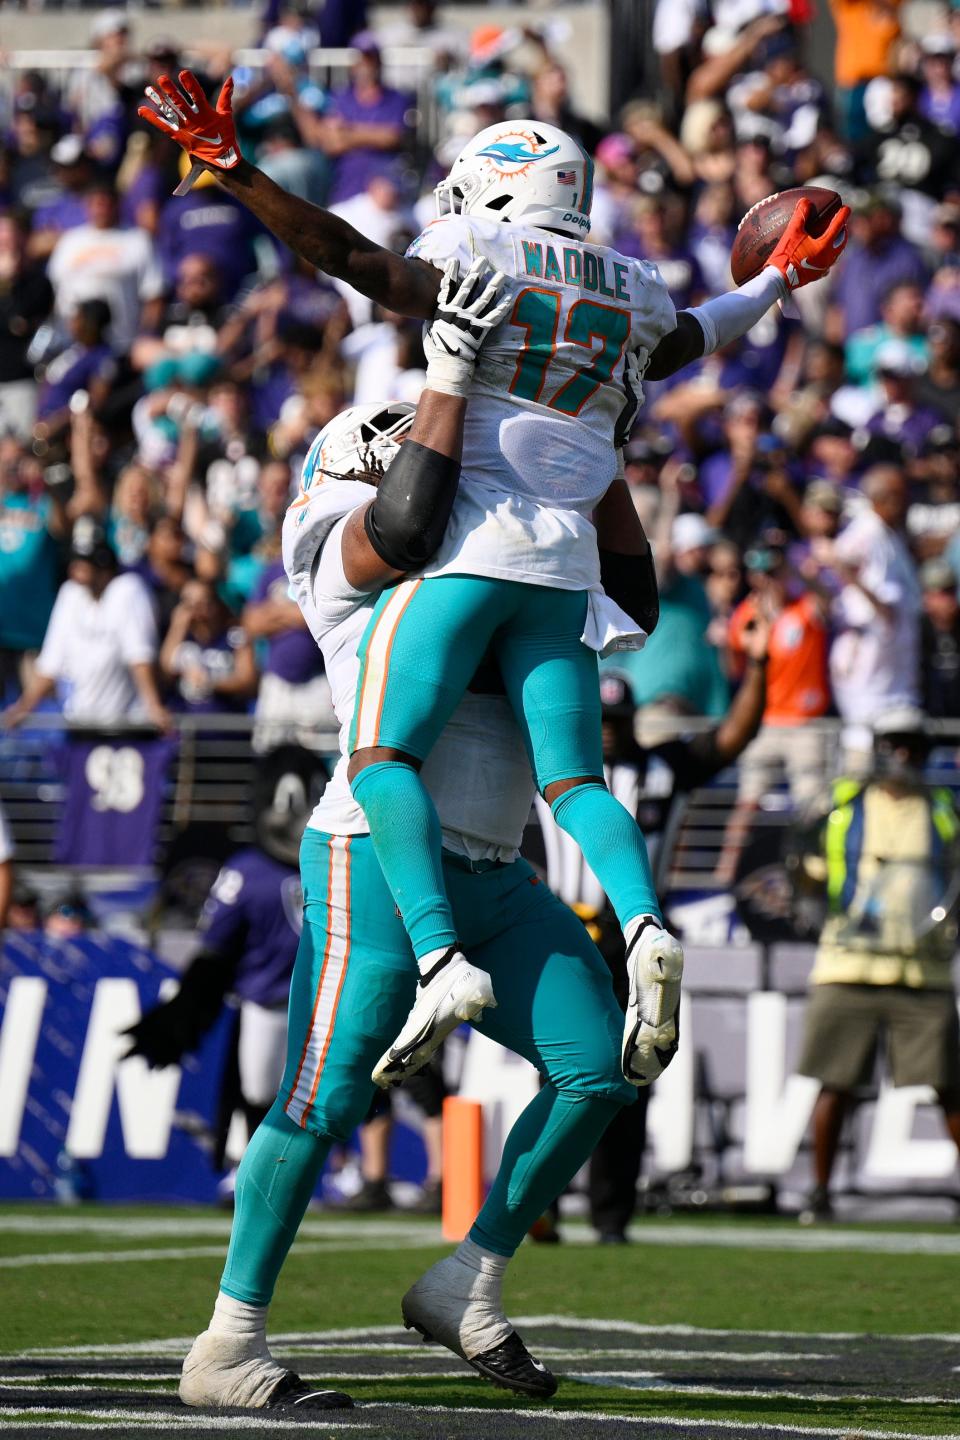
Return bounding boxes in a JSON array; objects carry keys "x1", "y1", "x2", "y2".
[{"x1": 407, "y1": 215, "x2": 676, "y2": 590}]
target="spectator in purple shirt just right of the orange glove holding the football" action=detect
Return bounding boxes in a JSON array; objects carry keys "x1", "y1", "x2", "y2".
[{"x1": 832, "y1": 194, "x2": 928, "y2": 336}]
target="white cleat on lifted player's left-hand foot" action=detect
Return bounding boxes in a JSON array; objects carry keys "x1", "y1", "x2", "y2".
[{"x1": 373, "y1": 946, "x2": 497, "y2": 1090}]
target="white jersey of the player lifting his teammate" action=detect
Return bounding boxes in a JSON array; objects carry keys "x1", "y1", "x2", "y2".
[{"x1": 284, "y1": 475, "x2": 535, "y2": 860}]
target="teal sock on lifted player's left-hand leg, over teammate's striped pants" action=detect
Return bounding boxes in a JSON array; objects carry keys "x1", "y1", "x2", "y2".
[{"x1": 350, "y1": 760, "x2": 456, "y2": 959}]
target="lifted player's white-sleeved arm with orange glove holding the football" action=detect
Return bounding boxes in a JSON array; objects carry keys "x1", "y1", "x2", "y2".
[{"x1": 645, "y1": 200, "x2": 851, "y2": 380}]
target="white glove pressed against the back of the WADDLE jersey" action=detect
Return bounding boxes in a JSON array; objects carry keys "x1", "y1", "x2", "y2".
[{"x1": 423, "y1": 255, "x2": 510, "y2": 396}]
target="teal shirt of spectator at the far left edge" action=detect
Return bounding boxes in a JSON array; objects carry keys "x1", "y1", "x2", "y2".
[{"x1": 0, "y1": 492, "x2": 60, "y2": 649}]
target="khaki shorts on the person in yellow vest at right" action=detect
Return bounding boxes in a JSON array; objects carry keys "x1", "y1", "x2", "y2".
[{"x1": 797, "y1": 985, "x2": 960, "y2": 1094}]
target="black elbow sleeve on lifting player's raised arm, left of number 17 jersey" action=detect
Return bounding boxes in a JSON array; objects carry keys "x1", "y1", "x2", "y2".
[{"x1": 363, "y1": 441, "x2": 461, "y2": 572}]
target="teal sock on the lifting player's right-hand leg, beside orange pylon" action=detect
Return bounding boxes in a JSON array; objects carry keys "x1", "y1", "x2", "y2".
[{"x1": 469, "y1": 1084, "x2": 623, "y2": 1256}]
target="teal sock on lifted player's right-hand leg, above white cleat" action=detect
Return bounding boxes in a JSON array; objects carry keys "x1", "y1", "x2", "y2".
[{"x1": 550, "y1": 785, "x2": 664, "y2": 927}]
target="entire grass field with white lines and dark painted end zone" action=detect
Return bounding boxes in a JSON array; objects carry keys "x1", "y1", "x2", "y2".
[{"x1": 0, "y1": 1207, "x2": 960, "y2": 1440}]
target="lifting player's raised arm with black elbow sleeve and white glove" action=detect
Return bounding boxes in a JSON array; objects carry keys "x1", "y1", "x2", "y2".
[{"x1": 341, "y1": 259, "x2": 510, "y2": 590}]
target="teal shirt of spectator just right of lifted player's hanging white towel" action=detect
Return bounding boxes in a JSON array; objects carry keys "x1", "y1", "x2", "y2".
[{"x1": 603, "y1": 575, "x2": 730, "y2": 716}]
